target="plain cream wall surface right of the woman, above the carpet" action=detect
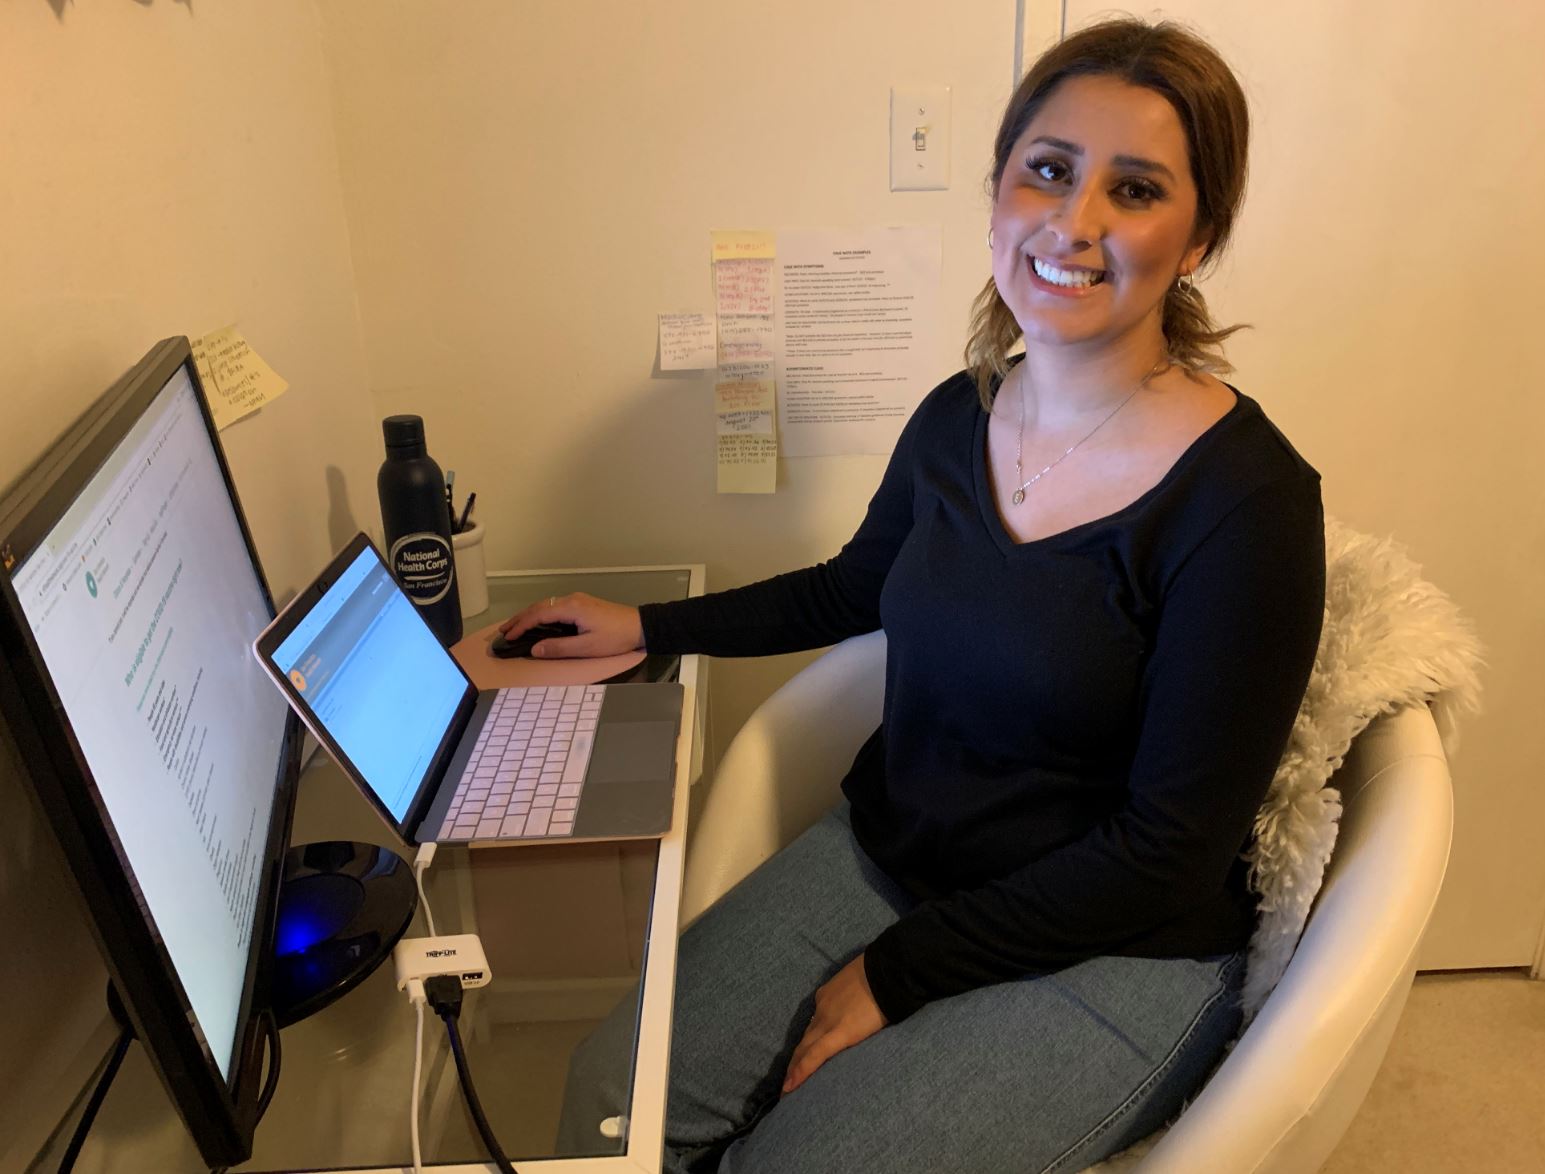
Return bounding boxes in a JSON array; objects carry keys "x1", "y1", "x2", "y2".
[{"x1": 1056, "y1": 0, "x2": 1545, "y2": 969}]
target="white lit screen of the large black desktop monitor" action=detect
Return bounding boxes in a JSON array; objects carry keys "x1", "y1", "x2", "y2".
[{"x1": 11, "y1": 355, "x2": 286, "y2": 1080}]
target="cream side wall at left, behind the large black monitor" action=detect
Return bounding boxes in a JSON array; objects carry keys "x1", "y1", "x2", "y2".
[{"x1": 0, "y1": 0, "x2": 379, "y2": 1169}]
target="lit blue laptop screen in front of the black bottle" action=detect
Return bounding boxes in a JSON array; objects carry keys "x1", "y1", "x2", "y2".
[{"x1": 272, "y1": 545, "x2": 470, "y2": 822}]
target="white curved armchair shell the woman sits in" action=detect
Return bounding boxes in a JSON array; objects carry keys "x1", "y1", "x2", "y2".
[{"x1": 683, "y1": 633, "x2": 1454, "y2": 1174}]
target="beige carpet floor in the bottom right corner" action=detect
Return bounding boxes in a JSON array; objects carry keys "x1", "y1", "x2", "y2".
[{"x1": 1321, "y1": 970, "x2": 1545, "y2": 1174}]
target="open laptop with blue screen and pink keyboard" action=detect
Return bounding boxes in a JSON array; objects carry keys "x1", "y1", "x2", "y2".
[{"x1": 253, "y1": 534, "x2": 683, "y2": 843}]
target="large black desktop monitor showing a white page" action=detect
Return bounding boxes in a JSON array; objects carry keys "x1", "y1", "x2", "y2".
[{"x1": 0, "y1": 338, "x2": 300, "y2": 1166}]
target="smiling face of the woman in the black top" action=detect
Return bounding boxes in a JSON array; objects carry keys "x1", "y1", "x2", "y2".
[{"x1": 992, "y1": 77, "x2": 1207, "y2": 353}]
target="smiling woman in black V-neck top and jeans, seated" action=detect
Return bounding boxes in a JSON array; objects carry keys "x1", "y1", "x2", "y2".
[{"x1": 543, "y1": 22, "x2": 1324, "y2": 1174}]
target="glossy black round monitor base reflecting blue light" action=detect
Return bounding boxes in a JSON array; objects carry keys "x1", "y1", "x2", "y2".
[{"x1": 270, "y1": 840, "x2": 419, "y2": 1027}]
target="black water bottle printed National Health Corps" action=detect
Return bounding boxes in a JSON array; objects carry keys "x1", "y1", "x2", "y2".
[{"x1": 375, "y1": 416, "x2": 462, "y2": 647}]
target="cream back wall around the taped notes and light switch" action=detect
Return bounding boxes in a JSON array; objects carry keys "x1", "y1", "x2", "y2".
[{"x1": 320, "y1": 0, "x2": 1015, "y2": 766}]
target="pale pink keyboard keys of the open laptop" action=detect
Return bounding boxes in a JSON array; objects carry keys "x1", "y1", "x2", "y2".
[{"x1": 440, "y1": 684, "x2": 606, "y2": 840}]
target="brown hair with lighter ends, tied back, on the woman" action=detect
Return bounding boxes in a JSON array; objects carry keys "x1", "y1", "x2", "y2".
[{"x1": 966, "y1": 19, "x2": 1250, "y2": 411}]
